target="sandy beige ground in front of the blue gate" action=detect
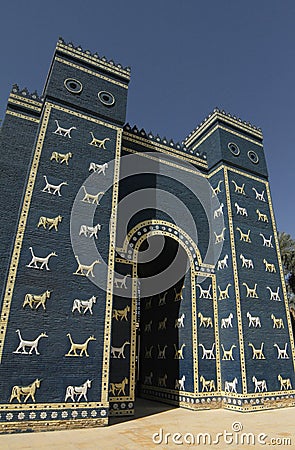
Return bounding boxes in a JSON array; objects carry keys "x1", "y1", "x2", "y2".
[{"x1": 0, "y1": 400, "x2": 295, "y2": 450}]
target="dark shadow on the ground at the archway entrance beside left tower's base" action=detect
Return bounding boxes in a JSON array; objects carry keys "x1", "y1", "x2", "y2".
[{"x1": 109, "y1": 398, "x2": 178, "y2": 425}]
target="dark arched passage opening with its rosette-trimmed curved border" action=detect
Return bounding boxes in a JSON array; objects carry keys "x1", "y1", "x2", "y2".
[{"x1": 130, "y1": 220, "x2": 206, "y2": 405}]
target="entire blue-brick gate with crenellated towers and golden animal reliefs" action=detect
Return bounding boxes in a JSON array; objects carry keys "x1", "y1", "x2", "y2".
[{"x1": 0, "y1": 39, "x2": 295, "y2": 432}]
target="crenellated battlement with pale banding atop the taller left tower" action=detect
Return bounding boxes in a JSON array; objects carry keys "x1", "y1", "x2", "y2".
[{"x1": 56, "y1": 37, "x2": 131, "y2": 80}]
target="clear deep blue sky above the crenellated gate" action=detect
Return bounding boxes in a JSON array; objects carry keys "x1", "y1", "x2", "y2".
[{"x1": 0, "y1": 0, "x2": 295, "y2": 238}]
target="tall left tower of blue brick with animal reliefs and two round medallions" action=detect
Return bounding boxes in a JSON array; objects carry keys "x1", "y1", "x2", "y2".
[{"x1": 1, "y1": 39, "x2": 130, "y2": 429}]
